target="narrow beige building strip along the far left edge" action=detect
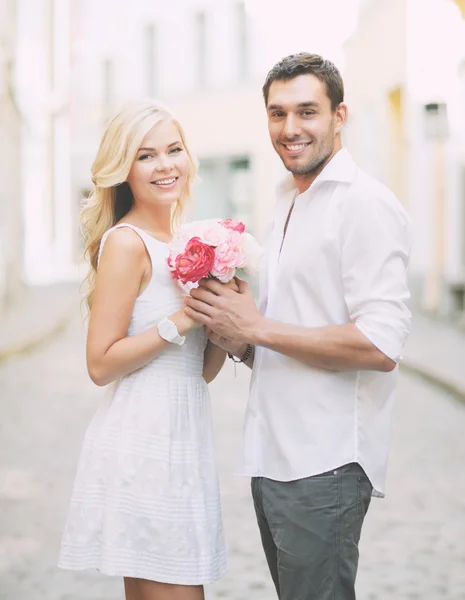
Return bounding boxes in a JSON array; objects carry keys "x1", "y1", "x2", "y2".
[{"x1": 0, "y1": 0, "x2": 23, "y2": 313}]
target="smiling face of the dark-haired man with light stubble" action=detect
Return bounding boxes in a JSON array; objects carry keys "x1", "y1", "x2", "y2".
[{"x1": 267, "y1": 75, "x2": 345, "y2": 179}]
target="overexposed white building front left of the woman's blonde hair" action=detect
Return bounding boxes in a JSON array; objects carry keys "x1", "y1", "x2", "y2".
[{"x1": 16, "y1": 0, "x2": 76, "y2": 284}]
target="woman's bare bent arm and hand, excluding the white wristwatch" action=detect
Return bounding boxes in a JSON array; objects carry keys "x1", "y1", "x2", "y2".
[{"x1": 86, "y1": 229, "x2": 197, "y2": 385}]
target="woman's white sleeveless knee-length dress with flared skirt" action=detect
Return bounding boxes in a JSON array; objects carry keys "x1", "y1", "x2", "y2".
[{"x1": 58, "y1": 223, "x2": 226, "y2": 585}]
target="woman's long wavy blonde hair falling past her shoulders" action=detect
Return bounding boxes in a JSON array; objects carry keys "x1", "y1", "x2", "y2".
[{"x1": 81, "y1": 100, "x2": 197, "y2": 309}]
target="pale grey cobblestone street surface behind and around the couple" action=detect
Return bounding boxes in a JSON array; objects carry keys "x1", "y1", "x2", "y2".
[{"x1": 0, "y1": 319, "x2": 465, "y2": 600}]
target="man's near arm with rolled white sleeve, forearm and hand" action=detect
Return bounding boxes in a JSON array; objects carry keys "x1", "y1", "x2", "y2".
[{"x1": 186, "y1": 190, "x2": 410, "y2": 371}]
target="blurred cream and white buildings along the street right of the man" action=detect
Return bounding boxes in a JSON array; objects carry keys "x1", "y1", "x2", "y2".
[{"x1": 345, "y1": 0, "x2": 465, "y2": 314}]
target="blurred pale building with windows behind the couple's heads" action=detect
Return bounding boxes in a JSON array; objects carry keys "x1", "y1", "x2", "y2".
[{"x1": 71, "y1": 0, "x2": 356, "y2": 248}]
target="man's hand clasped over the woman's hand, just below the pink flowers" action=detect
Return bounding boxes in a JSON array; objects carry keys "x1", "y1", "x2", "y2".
[{"x1": 185, "y1": 278, "x2": 262, "y2": 344}]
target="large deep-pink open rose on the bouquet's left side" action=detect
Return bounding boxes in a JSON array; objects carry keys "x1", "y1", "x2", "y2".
[{"x1": 168, "y1": 237, "x2": 215, "y2": 285}]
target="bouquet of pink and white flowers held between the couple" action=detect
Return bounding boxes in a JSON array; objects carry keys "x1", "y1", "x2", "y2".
[{"x1": 167, "y1": 219, "x2": 261, "y2": 285}]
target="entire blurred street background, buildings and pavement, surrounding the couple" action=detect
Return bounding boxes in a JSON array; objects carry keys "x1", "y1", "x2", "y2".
[{"x1": 0, "y1": 0, "x2": 465, "y2": 600}]
